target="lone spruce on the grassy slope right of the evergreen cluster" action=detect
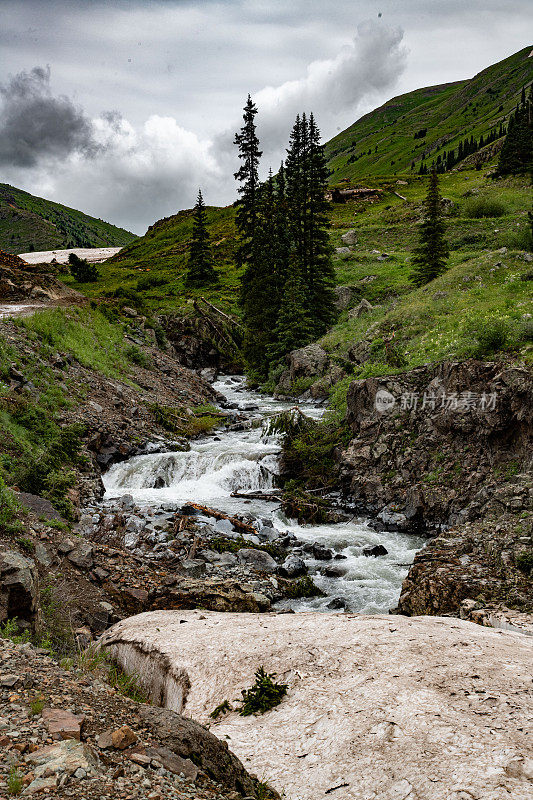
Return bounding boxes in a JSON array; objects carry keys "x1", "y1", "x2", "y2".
[{"x1": 411, "y1": 169, "x2": 449, "y2": 286}]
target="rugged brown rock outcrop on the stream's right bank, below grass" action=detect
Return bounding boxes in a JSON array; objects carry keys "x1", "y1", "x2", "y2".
[{"x1": 340, "y1": 361, "x2": 533, "y2": 614}]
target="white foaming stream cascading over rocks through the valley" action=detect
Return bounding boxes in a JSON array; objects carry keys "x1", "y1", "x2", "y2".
[{"x1": 104, "y1": 377, "x2": 423, "y2": 614}]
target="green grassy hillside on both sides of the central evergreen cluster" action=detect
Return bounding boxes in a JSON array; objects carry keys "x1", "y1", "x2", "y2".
[{"x1": 64, "y1": 170, "x2": 533, "y2": 374}]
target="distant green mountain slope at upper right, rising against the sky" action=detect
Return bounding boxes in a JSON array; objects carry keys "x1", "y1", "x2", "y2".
[{"x1": 326, "y1": 46, "x2": 533, "y2": 184}]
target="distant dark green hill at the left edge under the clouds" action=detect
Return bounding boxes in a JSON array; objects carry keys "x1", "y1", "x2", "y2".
[{"x1": 0, "y1": 183, "x2": 136, "y2": 253}]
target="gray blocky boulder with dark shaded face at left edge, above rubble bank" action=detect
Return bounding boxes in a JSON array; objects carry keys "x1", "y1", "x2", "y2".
[{"x1": 0, "y1": 546, "x2": 39, "y2": 624}]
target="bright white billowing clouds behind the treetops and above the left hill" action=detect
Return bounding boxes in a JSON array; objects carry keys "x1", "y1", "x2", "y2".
[{"x1": 1, "y1": 23, "x2": 405, "y2": 232}]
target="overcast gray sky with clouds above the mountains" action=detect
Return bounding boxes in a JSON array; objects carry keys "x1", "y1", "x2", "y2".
[{"x1": 0, "y1": 0, "x2": 533, "y2": 233}]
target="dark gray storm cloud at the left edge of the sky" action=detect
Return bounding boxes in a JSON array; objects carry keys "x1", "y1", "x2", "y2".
[{"x1": 0, "y1": 67, "x2": 99, "y2": 167}]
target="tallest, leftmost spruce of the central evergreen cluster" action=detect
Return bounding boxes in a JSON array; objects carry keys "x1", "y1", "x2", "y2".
[{"x1": 234, "y1": 95, "x2": 262, "y2": 272}]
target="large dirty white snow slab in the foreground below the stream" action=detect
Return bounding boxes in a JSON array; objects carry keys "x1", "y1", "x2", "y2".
[{"x1": 100, "y1": 611, "x2": 533, "y2": 800}]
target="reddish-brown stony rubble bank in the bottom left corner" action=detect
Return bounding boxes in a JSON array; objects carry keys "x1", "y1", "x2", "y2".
[{"x1": 0, "y1": 639, "x2": 257, "y2": 800}]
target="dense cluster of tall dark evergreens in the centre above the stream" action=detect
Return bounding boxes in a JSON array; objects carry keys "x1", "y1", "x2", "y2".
[{"x1": 235, "y1": 97, "x2": 335, "y2": 379}]
